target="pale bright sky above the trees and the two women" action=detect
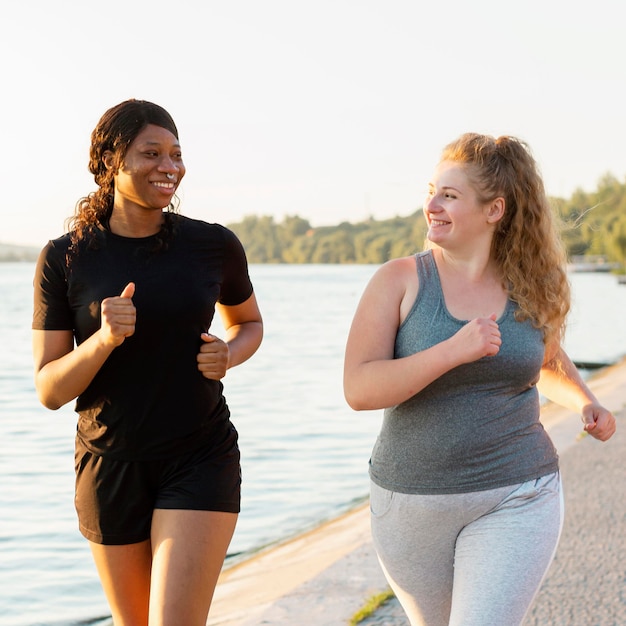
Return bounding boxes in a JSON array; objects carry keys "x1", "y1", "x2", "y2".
[{"x1": 0, "y1": 0, "x2": 626, "y2": 246}]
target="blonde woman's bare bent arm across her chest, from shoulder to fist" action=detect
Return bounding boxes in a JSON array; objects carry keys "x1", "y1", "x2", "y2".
[{"x1": 344, "y1": 257, "x2": 500, "y2": 411}]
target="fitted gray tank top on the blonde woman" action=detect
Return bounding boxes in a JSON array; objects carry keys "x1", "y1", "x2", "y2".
[{"x1": 370, "y1": 250, "x2": 558, "y2": 494}]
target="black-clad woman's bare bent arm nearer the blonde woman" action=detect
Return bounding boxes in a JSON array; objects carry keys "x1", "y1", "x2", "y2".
[{"x1": 197, "y1": 294, "x2": 263, "y2": 380}]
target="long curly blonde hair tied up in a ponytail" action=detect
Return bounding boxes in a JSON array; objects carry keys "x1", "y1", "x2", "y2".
[{"x1": 441, "y1": 133, "x2": 570, "y2": 349}]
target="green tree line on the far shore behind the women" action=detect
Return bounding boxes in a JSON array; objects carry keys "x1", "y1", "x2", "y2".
[{"x1": 227, "y1": 174, "x2": 626, "y2": 266}]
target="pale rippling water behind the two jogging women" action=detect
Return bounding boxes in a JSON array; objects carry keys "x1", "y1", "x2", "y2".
[{"x1": 0, "y1": 263, "x2": 626, "y2": 626}]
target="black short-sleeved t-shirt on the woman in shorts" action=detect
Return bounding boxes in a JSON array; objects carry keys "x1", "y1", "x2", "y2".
[{"x1": 33, "y1": 216, "x2": 252, "y2": 459}]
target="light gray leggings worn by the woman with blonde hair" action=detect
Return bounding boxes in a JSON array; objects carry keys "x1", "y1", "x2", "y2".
[{"x1": 370, "y1": 472, "x2": 563, "y2": 626}]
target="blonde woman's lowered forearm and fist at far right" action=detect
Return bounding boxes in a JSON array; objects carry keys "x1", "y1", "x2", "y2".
[{"x1": 537, "y1": 348, "x2": 615, "y2": 441}]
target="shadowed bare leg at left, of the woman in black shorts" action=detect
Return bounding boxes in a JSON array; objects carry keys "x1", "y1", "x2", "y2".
[{"x1": 89, "y1": 541, "x2": 152, "y2": 626}]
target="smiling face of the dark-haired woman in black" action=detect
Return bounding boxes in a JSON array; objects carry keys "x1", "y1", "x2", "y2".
[{"x1": 103, "y1": 124, "x2": 185, "y2": 211}]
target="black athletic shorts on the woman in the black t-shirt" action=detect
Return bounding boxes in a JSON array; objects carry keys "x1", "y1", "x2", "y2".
[{"x1": 75, "y1": 438, "x2": 241, "y2": 545}]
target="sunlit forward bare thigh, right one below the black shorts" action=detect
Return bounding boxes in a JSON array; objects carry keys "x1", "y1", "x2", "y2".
[{"x1": 147, "y1": 509, "x2": 237, "y2": 626}]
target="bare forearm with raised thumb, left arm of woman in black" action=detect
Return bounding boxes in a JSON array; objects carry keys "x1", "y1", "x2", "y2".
[{"x1": 33, "y1": 283, "x2": 136, "y2": 410}]
